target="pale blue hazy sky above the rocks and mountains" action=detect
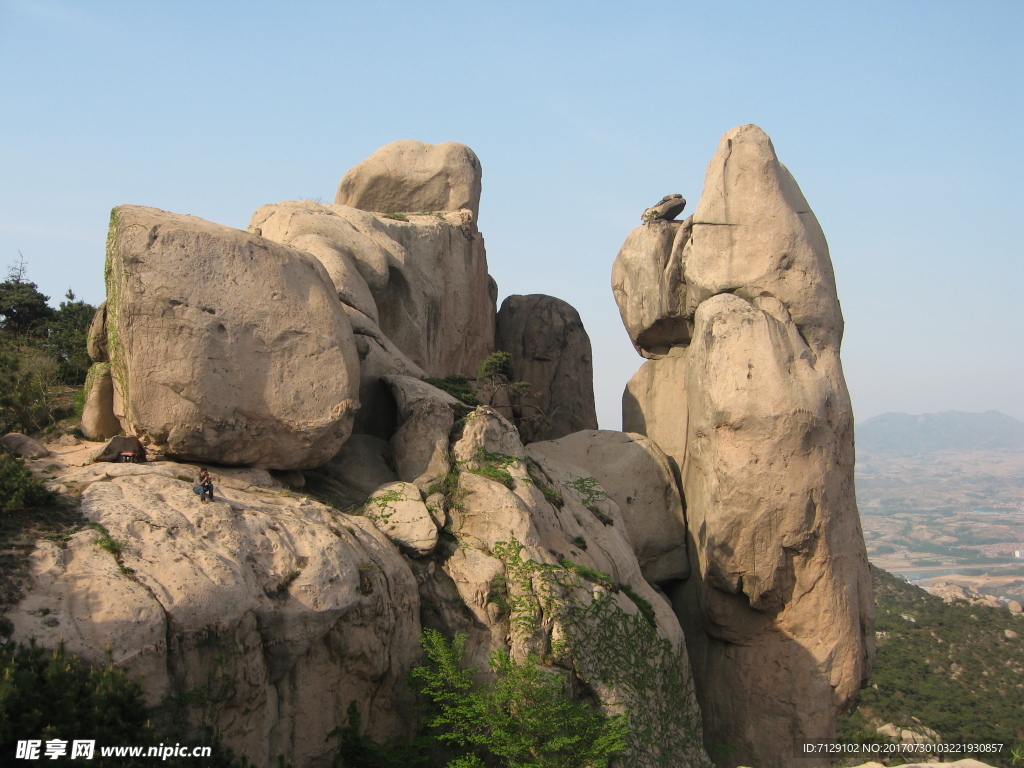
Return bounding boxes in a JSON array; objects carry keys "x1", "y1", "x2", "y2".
[{"x1": 0, "y1": 0, "x2": 1024, "y2": 429}]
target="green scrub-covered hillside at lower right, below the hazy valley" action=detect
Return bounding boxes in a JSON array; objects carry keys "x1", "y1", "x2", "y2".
[{"x1": 839, "y1": 566, "x2": 1024, "y2": 766}]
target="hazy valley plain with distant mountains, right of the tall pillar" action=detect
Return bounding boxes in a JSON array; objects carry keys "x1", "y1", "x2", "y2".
[{"x1": 856, "y1": 412, "x2": 1024, "y2": 600}]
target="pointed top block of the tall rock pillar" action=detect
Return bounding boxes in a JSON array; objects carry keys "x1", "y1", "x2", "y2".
[{"x1": 682, "y1": 125, "x2": 843, "y2": 353}]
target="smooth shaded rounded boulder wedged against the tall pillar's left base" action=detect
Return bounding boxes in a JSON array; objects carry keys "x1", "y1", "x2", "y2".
[{"x1": 526, "y1": 429, "x2": 690, "y2": 584}]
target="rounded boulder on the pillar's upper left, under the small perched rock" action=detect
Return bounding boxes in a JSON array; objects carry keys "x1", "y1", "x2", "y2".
[{"x1": 611, "y1": 217, "x2": 693, "y2": 358}]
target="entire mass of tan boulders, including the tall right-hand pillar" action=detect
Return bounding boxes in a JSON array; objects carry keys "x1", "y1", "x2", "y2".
[{"x1": 9, "y1": 132, "x2": 871, "y2": 768}]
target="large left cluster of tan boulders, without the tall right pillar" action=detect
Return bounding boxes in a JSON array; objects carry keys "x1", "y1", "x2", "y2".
[{"x1": 8, "y1": 142, "x2": 710, "y2": 768}]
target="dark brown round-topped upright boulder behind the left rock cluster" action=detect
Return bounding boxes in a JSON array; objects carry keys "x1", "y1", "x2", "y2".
[{"x1": 497, "y1": 294, "x2": 597, "y2": 442}]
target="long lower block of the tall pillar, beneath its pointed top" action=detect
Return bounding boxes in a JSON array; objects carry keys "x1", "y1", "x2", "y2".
[{"x1": 671, "y1": 294, "x2": 873, "y2": 767}]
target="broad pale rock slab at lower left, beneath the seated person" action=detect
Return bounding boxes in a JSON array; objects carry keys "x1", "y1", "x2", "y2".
[{"x1": 8, "y1": 446, "x2": 420, "y2": 766}]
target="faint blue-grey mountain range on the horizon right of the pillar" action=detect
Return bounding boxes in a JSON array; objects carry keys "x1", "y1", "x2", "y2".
[{"x1": 857, "y1": 411, "x2": 1024, "y2": 455}]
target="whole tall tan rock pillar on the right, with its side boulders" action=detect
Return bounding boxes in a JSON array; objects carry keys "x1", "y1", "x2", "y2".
[{"x1": 612, "y1": 126, "x2": 873, "y2": 768}]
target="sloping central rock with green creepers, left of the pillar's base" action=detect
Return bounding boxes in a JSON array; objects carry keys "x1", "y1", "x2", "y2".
[{"x1": 444, "y1": 407, "x2": 710, "y2": 768}]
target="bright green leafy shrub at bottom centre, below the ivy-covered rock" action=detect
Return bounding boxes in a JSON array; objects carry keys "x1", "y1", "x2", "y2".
[{"x1": 412, "y1": 630, "x2": 628, "y2": 768}]
